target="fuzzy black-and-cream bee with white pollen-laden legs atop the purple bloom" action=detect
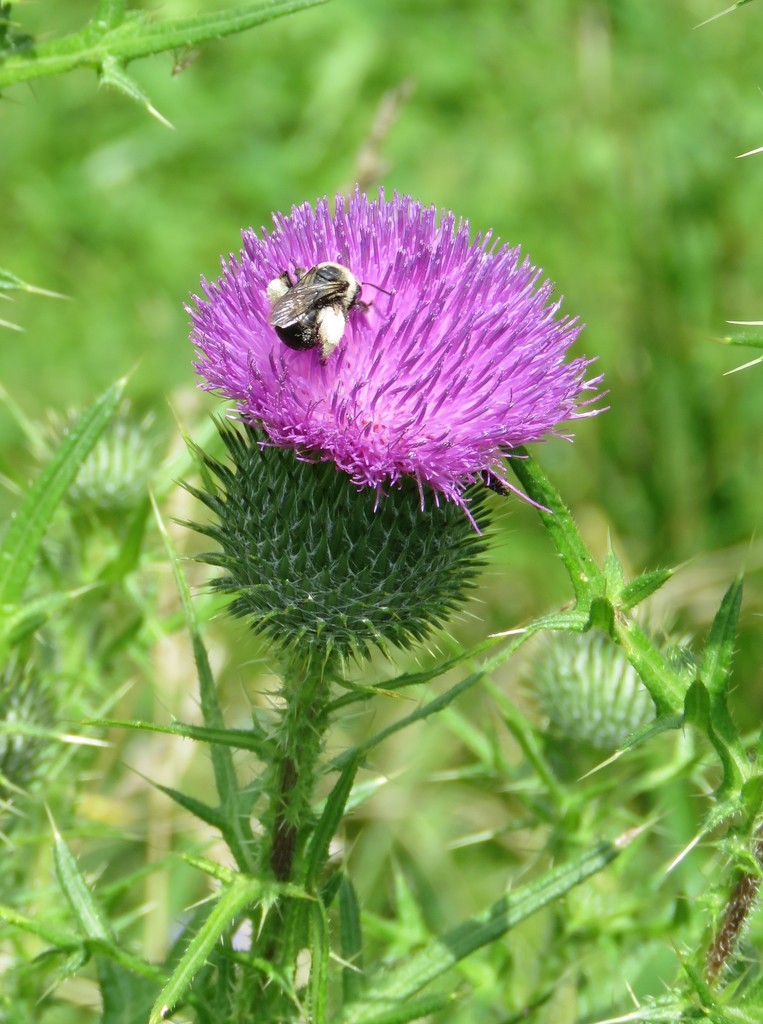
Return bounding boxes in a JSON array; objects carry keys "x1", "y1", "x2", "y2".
[{"x1": 267, "y1": 263, "x2": 369, "y2": 362}]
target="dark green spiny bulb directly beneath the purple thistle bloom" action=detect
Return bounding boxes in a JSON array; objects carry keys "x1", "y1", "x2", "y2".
[{"x1": 189, "y1": 427, "x2": 488, "y2": 657}]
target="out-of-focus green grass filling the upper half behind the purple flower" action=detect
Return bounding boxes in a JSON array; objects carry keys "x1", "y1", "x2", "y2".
[{"x1": 0, "y1": 0, "x2": 763, "y2": 692}]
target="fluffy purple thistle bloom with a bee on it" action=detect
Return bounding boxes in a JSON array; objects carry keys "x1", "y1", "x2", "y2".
[{"x1": 189, "y1": 191, "x2": 601, "y2": 509}]
